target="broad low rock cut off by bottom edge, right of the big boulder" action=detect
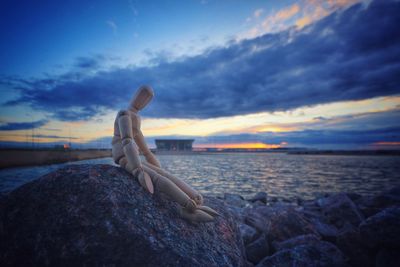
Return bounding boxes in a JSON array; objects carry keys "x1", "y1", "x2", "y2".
[{"x1": 256, "y1": 241, "x2": 347, "y2": 267}]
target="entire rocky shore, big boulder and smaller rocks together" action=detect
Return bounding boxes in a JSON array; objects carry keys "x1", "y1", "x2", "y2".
[{"x1": 0, "y1": 165, "x2": 400, "y2": 266}]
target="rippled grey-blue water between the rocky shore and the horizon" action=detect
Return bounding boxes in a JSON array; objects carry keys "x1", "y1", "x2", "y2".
[{"x1": 0, "y1": 153, "x2": 400, "y2": 199}]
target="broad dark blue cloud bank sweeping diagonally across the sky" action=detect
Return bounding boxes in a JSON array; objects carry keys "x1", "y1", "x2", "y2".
[{"x1": 3, "y1": 1, "x2": 400, "y2": 120}]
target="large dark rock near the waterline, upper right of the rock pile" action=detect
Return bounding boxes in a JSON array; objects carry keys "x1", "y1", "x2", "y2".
[{"x1": 317, "y1": 193, "x2": 364, "y2": 228}]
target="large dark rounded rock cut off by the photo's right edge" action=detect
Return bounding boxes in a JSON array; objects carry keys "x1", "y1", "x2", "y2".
[{"x1": 359, "y1": 206, "x2": 400, "y2": 248}]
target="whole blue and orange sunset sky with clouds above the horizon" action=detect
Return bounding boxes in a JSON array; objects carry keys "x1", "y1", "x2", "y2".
[{"x1": 0, "y1": 0, "x2": 400, "y2": 149}]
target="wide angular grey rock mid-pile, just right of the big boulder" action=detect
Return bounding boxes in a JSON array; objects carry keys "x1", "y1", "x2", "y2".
[{"x1": 245, "y1": 206, "x2": 319, "y2": 242}]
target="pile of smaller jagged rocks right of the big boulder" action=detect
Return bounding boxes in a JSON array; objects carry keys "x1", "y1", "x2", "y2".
[{"x1": 224, "y1": 187, "x2": 400, "y2": 266}]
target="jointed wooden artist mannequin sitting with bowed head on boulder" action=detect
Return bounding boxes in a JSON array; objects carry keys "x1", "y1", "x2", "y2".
[{"x1": 112, "y1": 86, "x2": 218, "y2": 222}]
